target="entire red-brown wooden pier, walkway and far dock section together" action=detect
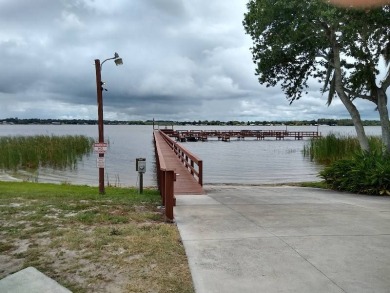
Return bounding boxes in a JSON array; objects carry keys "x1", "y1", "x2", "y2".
[{"x1": 153, "y1": 129, "x2": 321, "y2": 221}]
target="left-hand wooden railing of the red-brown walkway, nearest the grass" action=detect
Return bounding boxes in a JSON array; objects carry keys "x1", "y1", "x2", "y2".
[{"x1": 153, "y1": 133, "x2": 176, "y2": 221}]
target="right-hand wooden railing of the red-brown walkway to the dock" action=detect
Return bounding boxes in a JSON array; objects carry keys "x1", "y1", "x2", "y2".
[{"x1": 160, "y1": 130, "x2": 203, "y2": 186}]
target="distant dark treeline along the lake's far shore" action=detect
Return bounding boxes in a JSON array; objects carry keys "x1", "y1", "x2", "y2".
[{"x1": 0, "y1": 118, "x2": 380, "y2": 126}]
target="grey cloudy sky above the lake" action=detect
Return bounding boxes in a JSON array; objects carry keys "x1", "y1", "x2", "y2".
[{"x1": 0, "y1": 0, "x2": 386, "y2": 121}]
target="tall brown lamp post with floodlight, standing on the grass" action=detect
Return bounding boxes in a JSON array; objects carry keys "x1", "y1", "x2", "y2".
[{"x1": 95, "y1": 52, "x2": 123, "y2": 194}]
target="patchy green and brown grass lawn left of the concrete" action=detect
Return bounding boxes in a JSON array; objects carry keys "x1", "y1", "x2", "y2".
[{"x1": 0, "y1": 182, "x2": 194, "y2": 293}]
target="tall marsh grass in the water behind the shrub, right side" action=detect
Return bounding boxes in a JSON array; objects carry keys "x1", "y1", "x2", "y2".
[{"x1": 303, "y1": 134, "x2": 383, "y2": 165}]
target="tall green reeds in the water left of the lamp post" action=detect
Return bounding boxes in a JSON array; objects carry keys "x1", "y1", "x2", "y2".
[{"x1": 0, "y1": 135, "x2": 94, "y2": 171}]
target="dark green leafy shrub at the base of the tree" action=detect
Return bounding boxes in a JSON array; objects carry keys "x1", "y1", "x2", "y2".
[{"x1": 320, "y1": 151, "x2": 390, "y2": 195}]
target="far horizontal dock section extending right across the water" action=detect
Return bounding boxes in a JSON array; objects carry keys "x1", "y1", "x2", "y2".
[{"x1": 170, "y1": 129, "x2": 321, "y2": 142}]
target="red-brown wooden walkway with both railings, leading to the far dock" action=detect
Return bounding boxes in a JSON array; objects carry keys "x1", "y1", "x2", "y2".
[{"x1": 153, "y1": 130, "x2": 205, "y2": 220}]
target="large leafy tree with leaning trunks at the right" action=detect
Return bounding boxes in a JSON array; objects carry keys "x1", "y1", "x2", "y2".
[{"x1": 243, "y1": 0, "x2": 390, "y2": 152}]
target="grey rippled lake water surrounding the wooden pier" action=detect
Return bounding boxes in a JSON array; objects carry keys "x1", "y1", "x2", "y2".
[{"x1": 0, "y1": 125, "x2": 380, "y2": 186}]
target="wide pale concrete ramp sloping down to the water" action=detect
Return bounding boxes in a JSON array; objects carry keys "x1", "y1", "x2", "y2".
[{"x1": 174, "y1": 186, "x2": 390, "y2": 293}]
